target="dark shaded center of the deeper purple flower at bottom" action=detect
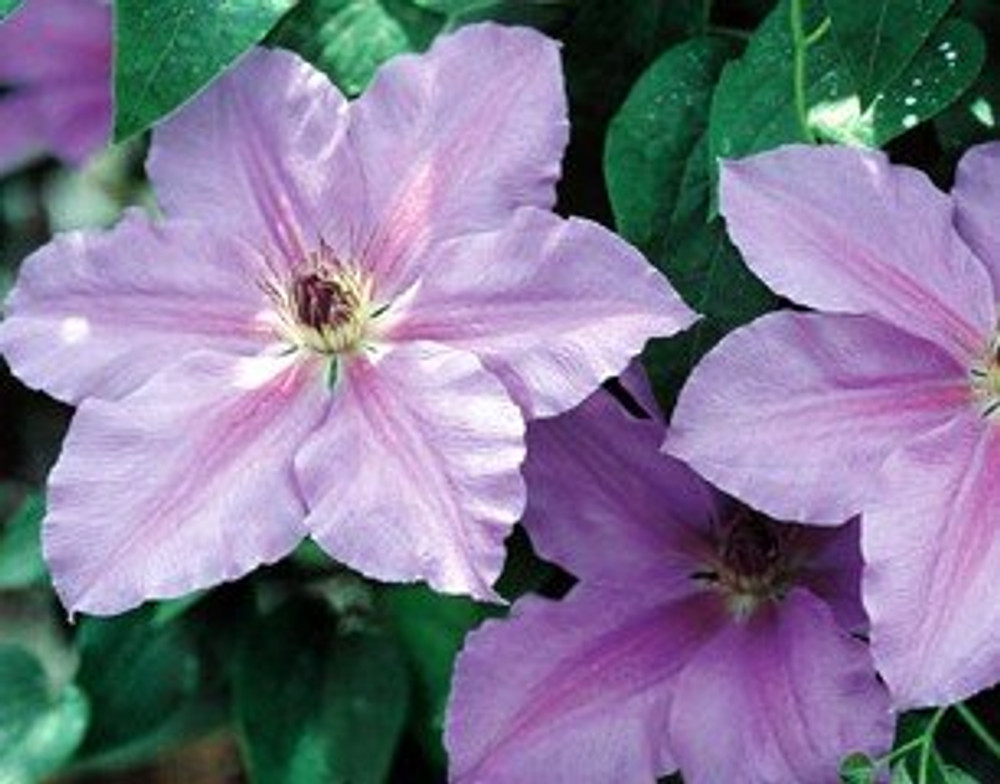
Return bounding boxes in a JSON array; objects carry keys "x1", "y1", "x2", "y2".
[{"x1": 694, "y1": 507, "x2": 793, "y2": 617}]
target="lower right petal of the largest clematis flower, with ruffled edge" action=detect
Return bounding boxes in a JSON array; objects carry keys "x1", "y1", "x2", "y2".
[{"x1": 295, "y1": 343, "x2": 524, "y2": 599}]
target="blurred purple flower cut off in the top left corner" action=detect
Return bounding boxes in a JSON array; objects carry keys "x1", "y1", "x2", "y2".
[{"x1": 0, "y1": 0, "x2": 111, "y2": 174}]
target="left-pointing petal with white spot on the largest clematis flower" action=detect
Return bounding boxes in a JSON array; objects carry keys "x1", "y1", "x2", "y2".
[{"x1": 0, "y1": 212, "x2": 268, "y2": 403}]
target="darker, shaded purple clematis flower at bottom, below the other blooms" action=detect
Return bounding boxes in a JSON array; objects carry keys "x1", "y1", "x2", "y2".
[{"x1": 446, "y1": 376, "x2": 893, "y2": 784}]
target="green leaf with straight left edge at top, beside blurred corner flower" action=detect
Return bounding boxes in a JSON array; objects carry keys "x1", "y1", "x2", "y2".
[{"x1": 114, "y1": 0, "x2": 295, "y2": 141}]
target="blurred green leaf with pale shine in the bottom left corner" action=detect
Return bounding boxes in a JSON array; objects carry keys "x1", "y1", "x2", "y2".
[{"x1": 0, "y1": 645, "x2": 89, "y2": 784}]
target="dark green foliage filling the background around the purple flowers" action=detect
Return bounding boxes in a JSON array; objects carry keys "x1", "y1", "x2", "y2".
[{"x1": 0, "y1": 0, "x2": 1000, "y2": 784}]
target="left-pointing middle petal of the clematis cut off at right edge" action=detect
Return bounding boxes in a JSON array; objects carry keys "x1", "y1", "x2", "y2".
[{"x1": 664, "y1": 312, "x2": 969, "y2": 524}]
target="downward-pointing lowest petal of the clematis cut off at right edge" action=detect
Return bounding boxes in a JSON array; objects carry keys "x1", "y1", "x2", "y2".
[{"x1": 862, "y1": 412, "x2": 1000, "y2": 708}]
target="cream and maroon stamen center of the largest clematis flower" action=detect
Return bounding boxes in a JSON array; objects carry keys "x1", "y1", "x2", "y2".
[{"x1": 268, "y1": 242, "x2": 373, "y2": 355}]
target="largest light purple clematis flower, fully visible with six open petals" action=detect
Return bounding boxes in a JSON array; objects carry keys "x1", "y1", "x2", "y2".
[{"x1": 0, "y1": 25, "x2": 693, "y2": 613}]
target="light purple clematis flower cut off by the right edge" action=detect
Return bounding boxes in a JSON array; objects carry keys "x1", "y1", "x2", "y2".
[{"x1": 667, "y1": 145, "x2": 1000, "y2": 707}]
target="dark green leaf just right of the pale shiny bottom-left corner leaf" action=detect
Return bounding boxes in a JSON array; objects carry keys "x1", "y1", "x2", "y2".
[{"x1": 77, "y1": 608, "x2": 200, "y2": 761}]
